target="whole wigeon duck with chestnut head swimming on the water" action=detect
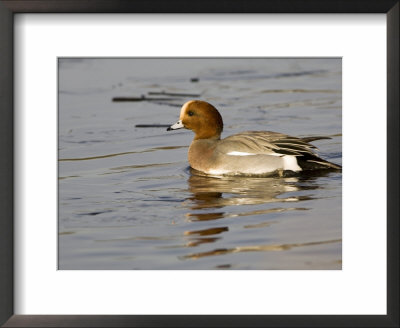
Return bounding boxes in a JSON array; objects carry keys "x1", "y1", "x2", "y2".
[{"x1": 167, "y1": 100, "x2": 341, "y2": 175}]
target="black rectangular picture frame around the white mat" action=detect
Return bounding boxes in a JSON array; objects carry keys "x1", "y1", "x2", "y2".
[{"x1": 0, "y1": 0, "x2": 400, "y2": 327}]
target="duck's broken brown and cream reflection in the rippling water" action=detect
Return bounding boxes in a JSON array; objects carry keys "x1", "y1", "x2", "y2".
[{"x1": 182, "y1": 169, "x2": 334, "y2": 259}]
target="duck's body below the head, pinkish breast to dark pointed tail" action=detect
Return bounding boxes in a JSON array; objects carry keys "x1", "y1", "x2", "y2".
[{"x1": 189, "y1": 131, "x2": 340, "y2": 175}]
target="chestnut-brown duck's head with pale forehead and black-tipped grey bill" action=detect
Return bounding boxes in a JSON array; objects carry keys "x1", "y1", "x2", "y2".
[{"x1": 167, "y1": 100, "x2": 224, "y2": 140}]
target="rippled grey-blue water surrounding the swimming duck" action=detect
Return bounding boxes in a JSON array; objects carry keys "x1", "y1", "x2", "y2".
[{"x1": 58, "y1": 58, "x2": 342, "y2": 270}]
